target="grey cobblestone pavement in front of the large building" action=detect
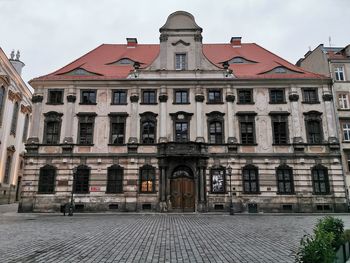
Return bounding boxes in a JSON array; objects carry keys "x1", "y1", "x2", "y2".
[{"x1": 0, "y1": 208, "x2": 350, "y2": 263}]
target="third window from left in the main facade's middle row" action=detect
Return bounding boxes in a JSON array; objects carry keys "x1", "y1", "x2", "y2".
[{"x1": 109, "y1": 113, "x2": 128, "y2": 144}]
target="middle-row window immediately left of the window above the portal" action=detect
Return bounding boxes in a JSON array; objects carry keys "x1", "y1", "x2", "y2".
[{"x1": 140, "y1": 111, "x2": 157, "y2": 143}]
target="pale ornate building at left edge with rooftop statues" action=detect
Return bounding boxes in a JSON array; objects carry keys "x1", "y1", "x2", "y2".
[{"x1": 0, "y1": 48, "x2": 32, "y2": 204}]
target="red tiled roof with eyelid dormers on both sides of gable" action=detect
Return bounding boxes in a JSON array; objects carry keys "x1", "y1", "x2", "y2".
[{"x1": 33, "y1": 44, "x2": 326, "y2": 80}]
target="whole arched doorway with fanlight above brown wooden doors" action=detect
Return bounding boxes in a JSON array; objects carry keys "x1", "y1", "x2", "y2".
[{"x1": 170, "y1": 166, "x2": 195, "y2": 212}]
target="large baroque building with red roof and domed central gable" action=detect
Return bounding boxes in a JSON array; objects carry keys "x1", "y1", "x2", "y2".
[{"x1": 20, "y1": 11, "x2": 347, "y2": 212}]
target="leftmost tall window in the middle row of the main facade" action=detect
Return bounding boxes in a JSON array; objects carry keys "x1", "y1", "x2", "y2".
[{"x1": 43, "y1": 111, "x2": 63, "y2": 144}]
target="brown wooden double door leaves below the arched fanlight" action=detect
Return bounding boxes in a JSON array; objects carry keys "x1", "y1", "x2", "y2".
[{"x1": 170, "y1": 177, "x2": 195, "y2": 212}]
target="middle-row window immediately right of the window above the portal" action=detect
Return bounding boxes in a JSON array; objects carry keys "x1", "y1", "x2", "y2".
[{"x1": 207, "y1": 111, "x2": 225, "y2": 144}]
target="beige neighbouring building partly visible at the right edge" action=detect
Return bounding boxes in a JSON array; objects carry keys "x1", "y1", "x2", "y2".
[{"x1": 297, "y1": 44, "x2": 350, "y2": 203}]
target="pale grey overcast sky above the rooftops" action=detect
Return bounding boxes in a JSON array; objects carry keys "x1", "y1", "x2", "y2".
[{"x1": 0, "y1": 0, "x2": 350, "y2": 84}]
